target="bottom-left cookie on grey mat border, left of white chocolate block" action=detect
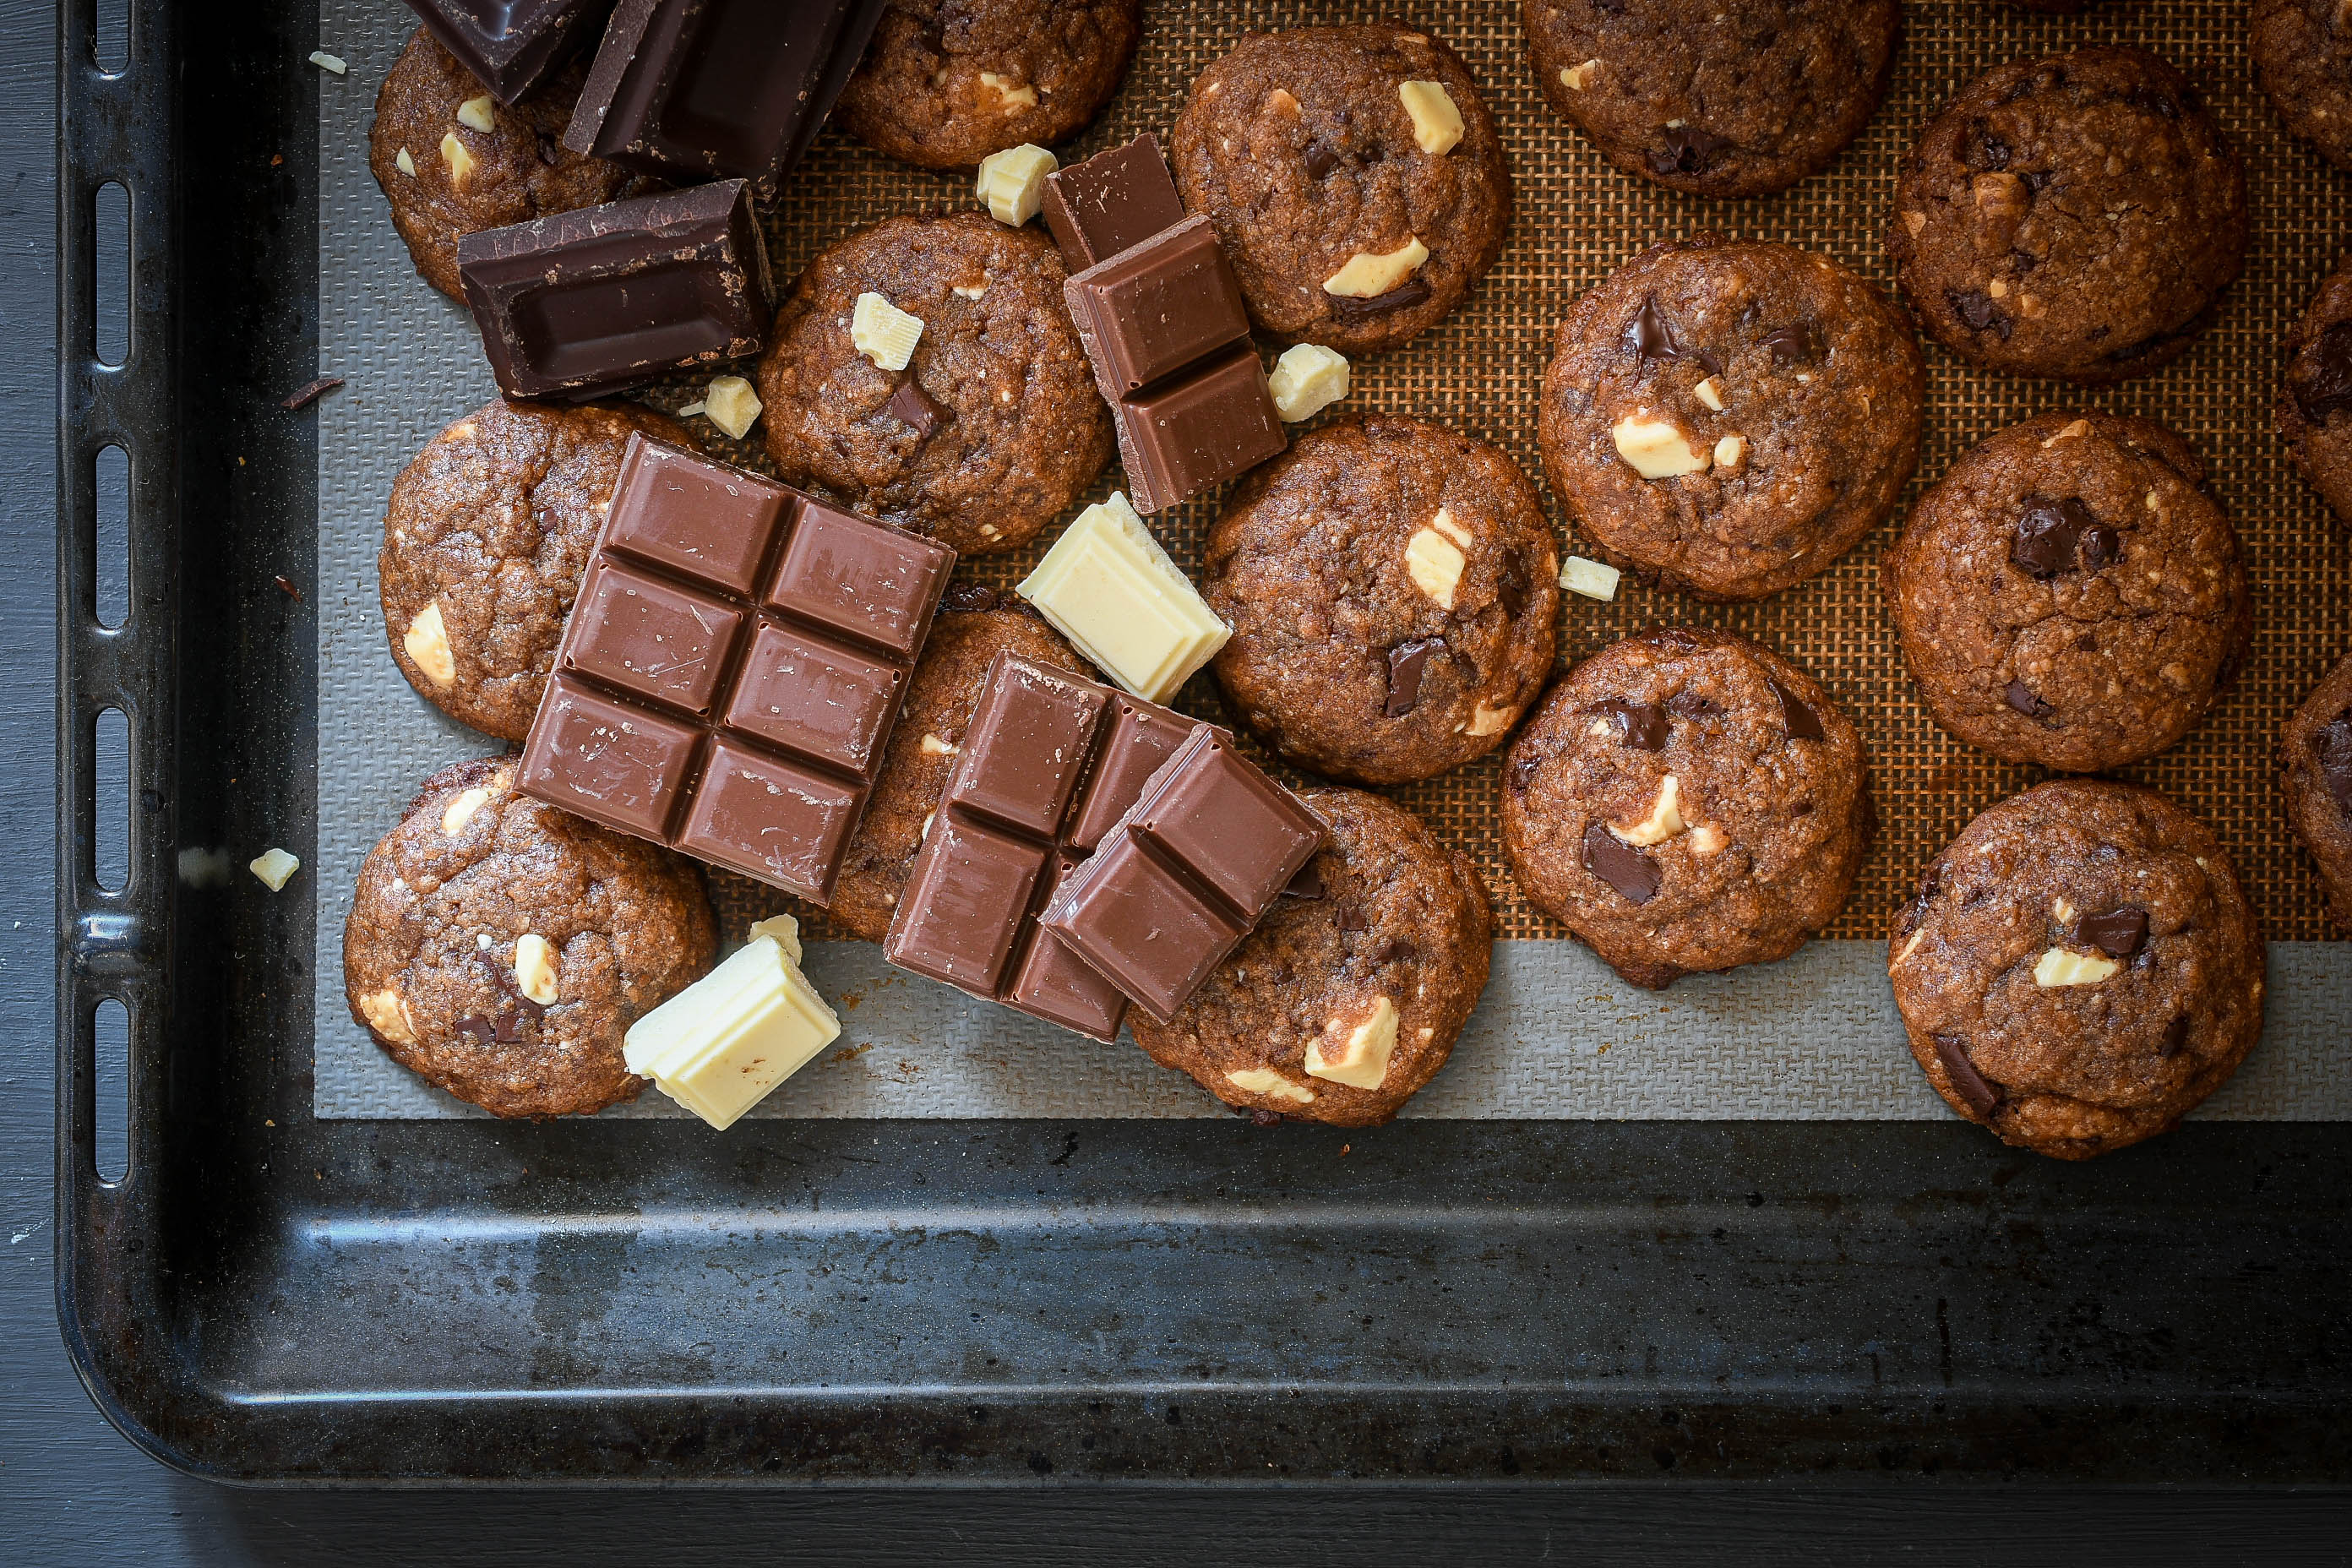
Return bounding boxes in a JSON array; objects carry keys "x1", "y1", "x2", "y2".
[{"x1": 343, "y1": 757, "x2": 717, "y2": 1117}]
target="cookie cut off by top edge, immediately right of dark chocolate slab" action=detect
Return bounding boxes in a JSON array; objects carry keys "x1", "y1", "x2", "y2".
[{"x1": 833, "y1": 0, "x2": 1143, "y2": 169}]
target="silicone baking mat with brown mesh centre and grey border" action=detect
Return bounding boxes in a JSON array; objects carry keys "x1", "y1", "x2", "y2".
[{"x1": 310, "y1": 0, "x2": 2352, "y2": 1119}]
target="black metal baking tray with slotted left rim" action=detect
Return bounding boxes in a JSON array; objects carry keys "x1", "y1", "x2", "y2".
[{"x1": 57, "y1": 0, "x2": 2352, "y2": 1484}]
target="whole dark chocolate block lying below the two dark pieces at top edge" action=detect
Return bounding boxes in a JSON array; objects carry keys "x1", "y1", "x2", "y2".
[{"x1": 456, "y1": 178, "x2": 769, "y2": 400}]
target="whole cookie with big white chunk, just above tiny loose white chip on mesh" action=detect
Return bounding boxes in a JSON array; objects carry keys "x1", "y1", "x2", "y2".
[{"x1": 1536, "y1": 235, "x2": 1926, "y2": 600}]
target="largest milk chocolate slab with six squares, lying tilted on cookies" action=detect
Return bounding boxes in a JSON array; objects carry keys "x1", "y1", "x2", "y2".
[{"x1": 517, "y1": 435, "x2": 955, "y2": 905}]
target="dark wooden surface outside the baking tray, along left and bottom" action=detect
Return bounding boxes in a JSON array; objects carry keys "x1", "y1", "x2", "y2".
[{"x1": 14, "y1": 0, "x2": 2352, "y2": 1568}]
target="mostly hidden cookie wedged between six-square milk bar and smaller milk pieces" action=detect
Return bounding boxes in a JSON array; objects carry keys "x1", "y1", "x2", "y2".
[{"x1": 825, "y1": 595, "x2": 1086, "y2": 943}]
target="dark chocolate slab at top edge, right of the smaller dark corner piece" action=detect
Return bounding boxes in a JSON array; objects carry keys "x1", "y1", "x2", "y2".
[{"x1": 564, "y1": 0, "x2": 885, "y2": 183}]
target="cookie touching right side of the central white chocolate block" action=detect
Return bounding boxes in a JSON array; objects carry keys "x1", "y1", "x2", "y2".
[{"x1": 1202, "y1": 414, "x2": 1560, "y2": 785}]
